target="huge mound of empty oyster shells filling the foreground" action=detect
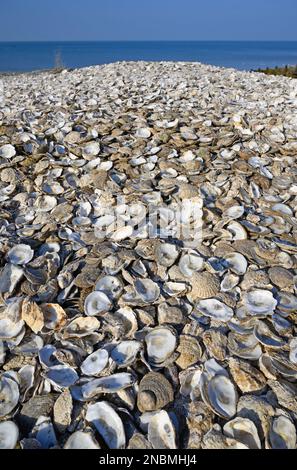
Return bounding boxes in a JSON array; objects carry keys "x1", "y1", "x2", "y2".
[{"x1": 0, "y1": 62, "x2": 297, "y2": 449}]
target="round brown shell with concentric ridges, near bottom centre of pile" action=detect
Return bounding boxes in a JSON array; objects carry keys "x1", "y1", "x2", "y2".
[{"x1": 137, "y1": 372, "x2": 174, "y2": 413}]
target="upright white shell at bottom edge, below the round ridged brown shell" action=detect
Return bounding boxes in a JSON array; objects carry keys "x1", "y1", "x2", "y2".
[{"x1": 148, "y1": 410, "x2": 177, "y2": 449}]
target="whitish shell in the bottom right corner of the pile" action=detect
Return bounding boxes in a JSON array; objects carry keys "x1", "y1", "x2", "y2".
[{"x1": 269, "y1": 416, "x2": 296, "y2": 449}]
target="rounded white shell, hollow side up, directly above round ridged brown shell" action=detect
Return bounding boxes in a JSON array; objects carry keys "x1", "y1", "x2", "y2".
[{"x1": 145, "y1": 326, "x2": 176, "y2": 367}]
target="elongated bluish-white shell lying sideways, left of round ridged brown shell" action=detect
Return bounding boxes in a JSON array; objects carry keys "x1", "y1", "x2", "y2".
[{"x1": 81, "y1": 372, "x2": 134, "y2": 399}]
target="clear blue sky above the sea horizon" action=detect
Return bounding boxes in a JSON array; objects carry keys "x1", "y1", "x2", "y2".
[{"x1": 0, "y1": 0, "x2": 297, "y2": 41}]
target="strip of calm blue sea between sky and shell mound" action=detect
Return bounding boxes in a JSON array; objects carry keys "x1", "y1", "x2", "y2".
[{"x1": 0, "y1": 41, "x2": 297, "y2": 72}]
